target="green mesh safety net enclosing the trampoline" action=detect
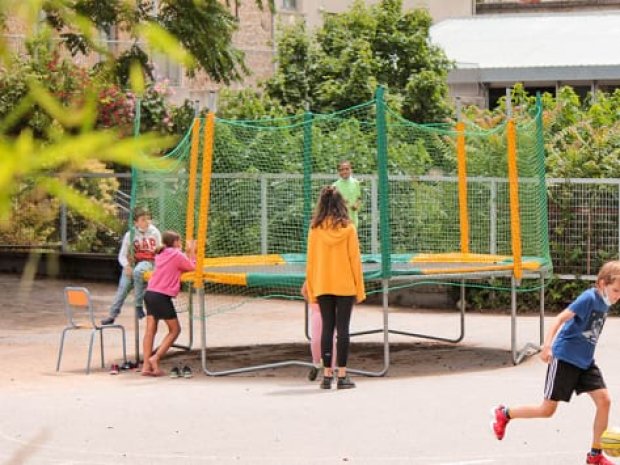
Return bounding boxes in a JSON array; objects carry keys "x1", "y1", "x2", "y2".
[{"x1": 133, "y1": 91, "x2": 551, "y2": 313}]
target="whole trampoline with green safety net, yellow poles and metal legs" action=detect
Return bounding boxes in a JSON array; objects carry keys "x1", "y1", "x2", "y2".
[{"x1": 132, "y1": 89, "x2": 552, "y2": 376}]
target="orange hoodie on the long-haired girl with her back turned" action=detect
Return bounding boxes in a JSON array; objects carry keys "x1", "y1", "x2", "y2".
[{"x1": 306, "y1": 223, "x2": 366, "y2": 303}]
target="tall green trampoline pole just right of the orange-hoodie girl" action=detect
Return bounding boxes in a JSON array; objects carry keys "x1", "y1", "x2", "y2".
[{"x1": 375, "y1": 86, "x2": 392, "y2": 279}]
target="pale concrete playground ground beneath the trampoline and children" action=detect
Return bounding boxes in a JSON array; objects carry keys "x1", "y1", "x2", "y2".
[{"x1": 0, "y1": 275, "x2": 620, "y2": 465}]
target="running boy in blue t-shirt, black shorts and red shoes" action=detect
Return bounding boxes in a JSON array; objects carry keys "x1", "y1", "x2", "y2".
[{"x1": 492, "y1": 261, "x2": 620, "y2": 465}]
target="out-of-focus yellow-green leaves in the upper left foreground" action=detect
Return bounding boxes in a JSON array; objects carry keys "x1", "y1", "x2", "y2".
[{"x1": 0, "y1": 0, "x2": 180, "y2": 223}]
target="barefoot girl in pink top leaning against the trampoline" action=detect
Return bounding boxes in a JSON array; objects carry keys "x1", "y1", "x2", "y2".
[{"x1": 142, "y1": 231, "x2": 196, "y2": 376}]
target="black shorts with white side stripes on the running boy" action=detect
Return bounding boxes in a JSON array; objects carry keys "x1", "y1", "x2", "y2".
[{"x1": 545, "y1": 357, "x2": 607, "y2": 402}]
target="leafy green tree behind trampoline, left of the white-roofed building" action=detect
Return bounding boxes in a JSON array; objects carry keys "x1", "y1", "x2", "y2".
[{"x1": 265, "y1": 0, "x2": 451, "y2": 122}]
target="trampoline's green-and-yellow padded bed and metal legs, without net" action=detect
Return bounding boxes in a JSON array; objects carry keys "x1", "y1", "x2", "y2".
[{"x1": 171, "y1": 252, "x2": 550, "y2": 376}]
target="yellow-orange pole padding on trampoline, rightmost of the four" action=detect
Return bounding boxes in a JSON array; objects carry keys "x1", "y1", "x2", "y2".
[{"x1": 506, "y1": 119, "x2": 523, "y2": 280}]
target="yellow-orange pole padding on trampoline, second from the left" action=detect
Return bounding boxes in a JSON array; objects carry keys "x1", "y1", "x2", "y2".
[{"x1": 194, "y1": 112, "x2": 215, "y2": 289}]
